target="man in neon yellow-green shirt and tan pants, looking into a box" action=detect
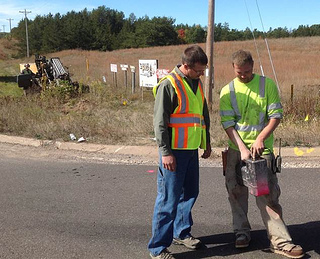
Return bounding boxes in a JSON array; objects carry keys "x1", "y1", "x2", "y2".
[{"x1": 220, "y1": 50, "x2": 304, "y2": 258}]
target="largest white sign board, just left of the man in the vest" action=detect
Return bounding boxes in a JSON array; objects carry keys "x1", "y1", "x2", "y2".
[{"x1": 139, "y1": 60, "x2": 158, "y2": 87}]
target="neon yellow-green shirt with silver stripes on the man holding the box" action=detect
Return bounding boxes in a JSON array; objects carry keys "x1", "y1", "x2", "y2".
[{"x1": 220, "y1": 75, "x2": 283, "y2": 154}]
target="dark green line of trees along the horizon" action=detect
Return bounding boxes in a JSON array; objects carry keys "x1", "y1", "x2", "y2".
[{"x1": 12, "y1": 6, "x2": 320, "y2": 54}]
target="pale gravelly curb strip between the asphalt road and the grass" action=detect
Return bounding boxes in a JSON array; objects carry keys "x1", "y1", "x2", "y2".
[{"x1": 0, "y1": 143, "x2": 320, "y2": 168}]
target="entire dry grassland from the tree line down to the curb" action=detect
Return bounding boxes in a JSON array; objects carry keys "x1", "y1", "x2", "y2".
[{"x1": 0, "y1": 37, "x2": 320, "y2": 146}]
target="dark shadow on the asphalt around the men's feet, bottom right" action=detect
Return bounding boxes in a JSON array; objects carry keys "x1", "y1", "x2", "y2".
[{"x1": 175, "y1": 221, "x2": 320, "y2": 259}]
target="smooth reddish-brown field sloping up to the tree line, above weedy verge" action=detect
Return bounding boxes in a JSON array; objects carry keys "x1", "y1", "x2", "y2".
[{"x1": 48, "y1": 37, "x2": 320, "y2": 92}]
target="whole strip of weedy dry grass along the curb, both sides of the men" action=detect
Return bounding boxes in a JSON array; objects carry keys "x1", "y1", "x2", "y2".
[{"x1": 0, "y1": 83, "x2": 320, "y2": 147}]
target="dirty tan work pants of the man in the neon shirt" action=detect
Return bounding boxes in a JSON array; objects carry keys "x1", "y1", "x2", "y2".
[{"x1": 225, "y1": 148, "x2": 292, "y2": 248}]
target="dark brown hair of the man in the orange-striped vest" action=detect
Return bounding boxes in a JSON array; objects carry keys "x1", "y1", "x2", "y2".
[{"x1": 181, "y1": 45, "x2": 208, "y2": 67}]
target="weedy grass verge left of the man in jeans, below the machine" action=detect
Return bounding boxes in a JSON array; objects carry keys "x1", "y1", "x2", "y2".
[{"x1": 0, "y1": 84, "x2": 153, "y2": 144}]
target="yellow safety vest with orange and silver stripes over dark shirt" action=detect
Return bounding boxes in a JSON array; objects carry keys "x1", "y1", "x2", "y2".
[{"x1": 153, "y1": 70, "x2": 207, "y2": 150}]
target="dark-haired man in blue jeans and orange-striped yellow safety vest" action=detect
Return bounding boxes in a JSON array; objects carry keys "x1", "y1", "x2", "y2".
[{"x1": 148, "y1": 45, "x2": 211, "y2": 259}]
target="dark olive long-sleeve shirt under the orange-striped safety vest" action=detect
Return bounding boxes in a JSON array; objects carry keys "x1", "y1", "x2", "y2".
[{"x1": 153, "y1": 66, "x2": 210, "y2": 156}]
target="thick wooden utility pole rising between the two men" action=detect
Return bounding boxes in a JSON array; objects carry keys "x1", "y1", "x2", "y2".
[{"x1": 205, "y1": 0, "x2": 215, "y2": 110}]
